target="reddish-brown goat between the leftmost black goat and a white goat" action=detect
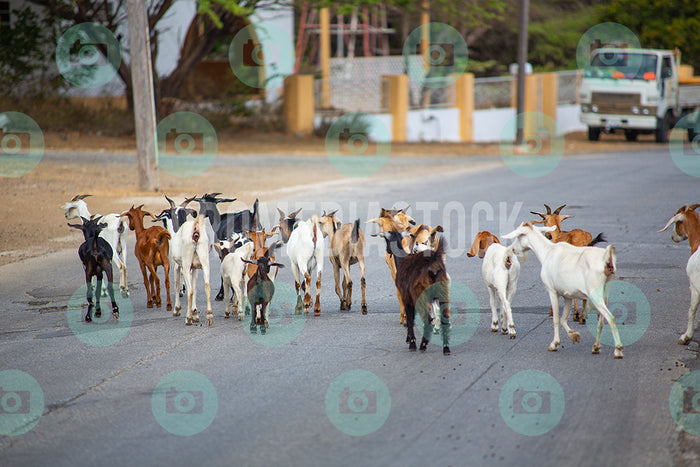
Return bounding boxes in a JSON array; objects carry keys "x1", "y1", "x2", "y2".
[{"x1": 121, "y1": 204, "x2": 173, "y2": 310}]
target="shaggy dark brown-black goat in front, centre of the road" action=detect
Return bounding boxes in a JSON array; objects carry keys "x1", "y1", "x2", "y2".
[{"x1": 378, "y1": 231, "x2": 450, "y2": 355}]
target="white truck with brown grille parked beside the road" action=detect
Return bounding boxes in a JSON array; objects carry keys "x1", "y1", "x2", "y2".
[{"x1": 579, "y1": 47, "x2": 700, "y2": 143}]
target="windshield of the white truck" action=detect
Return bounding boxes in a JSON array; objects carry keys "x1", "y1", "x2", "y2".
[{"x1": 584, "y1": 51, "x2": 658, "y2": 80}]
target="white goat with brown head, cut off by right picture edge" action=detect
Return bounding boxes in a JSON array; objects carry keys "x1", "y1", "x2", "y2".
[{"x1": 659, "y1": 204, "x2": 700, "y2": 345}]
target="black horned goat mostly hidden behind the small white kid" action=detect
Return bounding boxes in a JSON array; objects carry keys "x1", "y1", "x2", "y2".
[{"x1": 194, "y1": 193, "x2": 262, "y2": 301}]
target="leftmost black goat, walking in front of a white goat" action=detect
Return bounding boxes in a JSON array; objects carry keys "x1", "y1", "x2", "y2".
[{"x1": 68, "y1": 217, "x2": 119, "y2": 323}]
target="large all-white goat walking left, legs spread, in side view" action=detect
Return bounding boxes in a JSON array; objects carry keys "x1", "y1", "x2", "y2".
[{"x1": 503, "y1": 222, "x2": 622, "y2": 358}]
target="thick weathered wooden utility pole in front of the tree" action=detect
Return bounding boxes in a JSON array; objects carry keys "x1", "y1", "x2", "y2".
[{"x1": 126, "y1": 0, "x2": 159, "y2": 191}]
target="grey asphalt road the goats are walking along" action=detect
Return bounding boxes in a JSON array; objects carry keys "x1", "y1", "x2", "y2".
[{"x1": 0, "y1": 151, "x2": 698, "y2": 466}]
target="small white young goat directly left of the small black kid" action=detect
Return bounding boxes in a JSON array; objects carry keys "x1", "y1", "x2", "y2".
[{"x1": 214, "y1": 233, "x2": 255, "y2": 321}]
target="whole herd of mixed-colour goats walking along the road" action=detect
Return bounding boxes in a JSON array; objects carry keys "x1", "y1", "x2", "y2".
[{"x1": 61, "y1": 193, "x2": 700, "y2": 358}]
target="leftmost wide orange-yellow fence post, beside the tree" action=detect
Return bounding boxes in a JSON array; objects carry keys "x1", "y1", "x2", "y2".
[{"x1": 284, "y1": 75, "x2": 314, "y2": 135}]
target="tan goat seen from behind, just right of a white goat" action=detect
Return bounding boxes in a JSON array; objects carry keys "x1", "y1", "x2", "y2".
[{"x1": 321, "y1": 211, "x2": 367, "y2": 315}]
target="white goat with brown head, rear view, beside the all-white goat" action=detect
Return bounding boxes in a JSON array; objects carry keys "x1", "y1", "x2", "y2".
[{"x1": 467, "y1": 230, "x2": 520, "y2": 339}]
